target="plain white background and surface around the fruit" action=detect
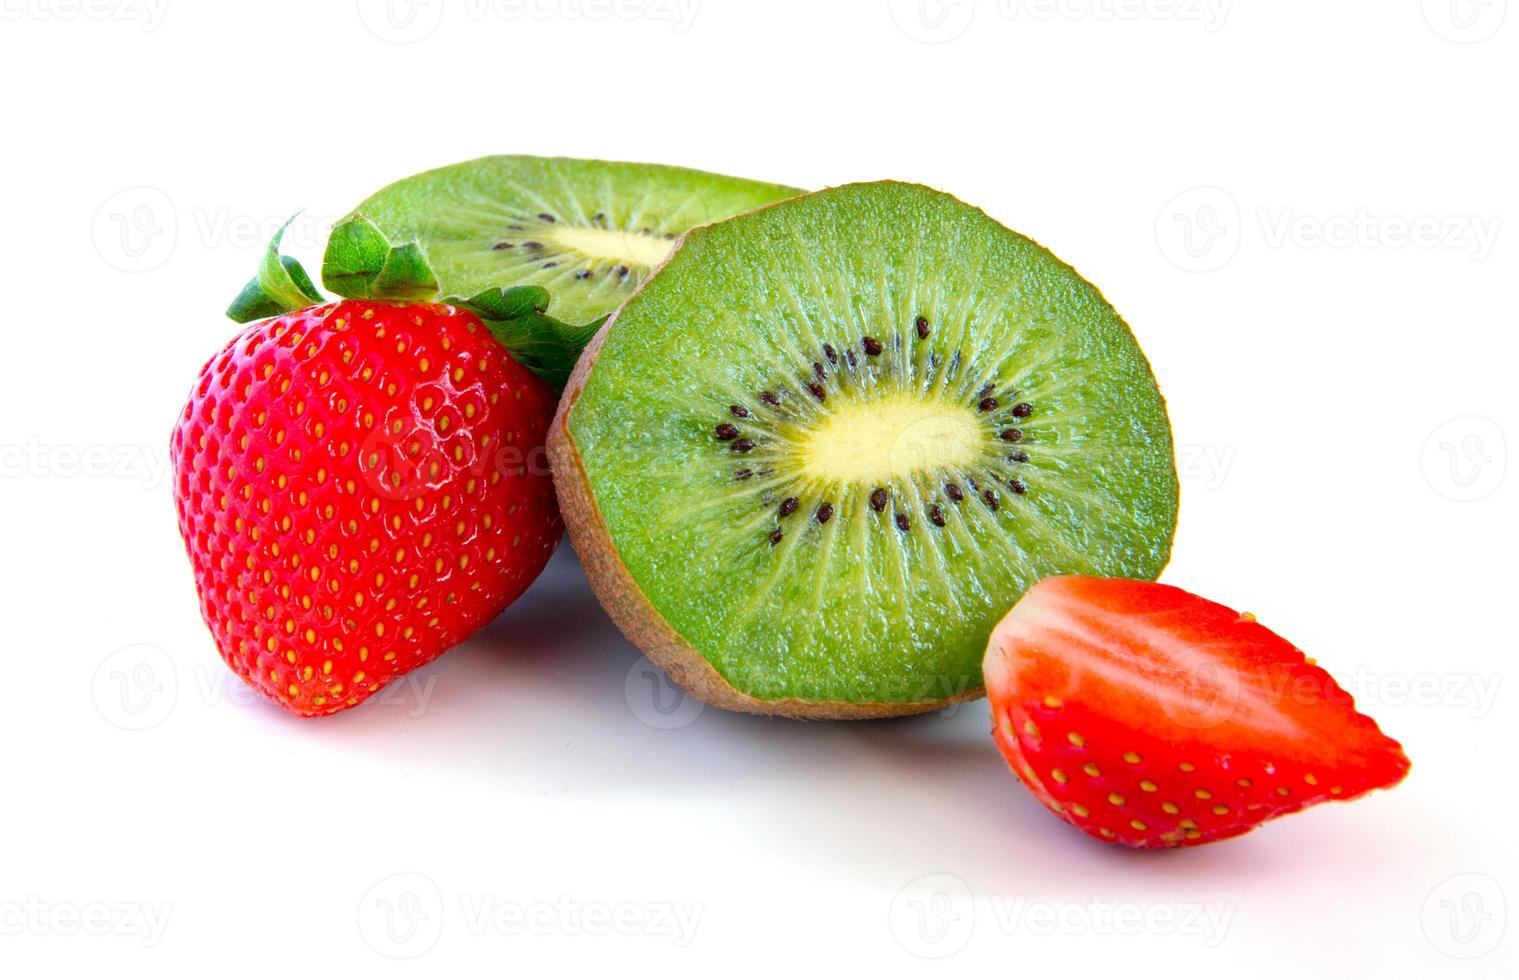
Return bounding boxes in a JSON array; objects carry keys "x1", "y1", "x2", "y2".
[{"x1": 0, "y1": 0, "x2": 1519, "y2": 977}]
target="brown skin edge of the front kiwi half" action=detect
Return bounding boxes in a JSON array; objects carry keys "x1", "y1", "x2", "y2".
[{"x1": 548, "y1": 258, "x2": 986, "y2": 720}]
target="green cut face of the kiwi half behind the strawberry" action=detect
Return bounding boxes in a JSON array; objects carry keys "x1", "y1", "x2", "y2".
[{"x1": 354, "y1": 156, "x2": 801, "y2": 324}]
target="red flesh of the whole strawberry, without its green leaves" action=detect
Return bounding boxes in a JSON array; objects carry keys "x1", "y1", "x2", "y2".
[{"x1": 170, "y1": 294, "x2": 561, "y2": 716}]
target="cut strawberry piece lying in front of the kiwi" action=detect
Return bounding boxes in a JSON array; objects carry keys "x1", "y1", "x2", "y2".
[{"x1": 984, "y1": 576, "x2": 1408, "y2": 848}]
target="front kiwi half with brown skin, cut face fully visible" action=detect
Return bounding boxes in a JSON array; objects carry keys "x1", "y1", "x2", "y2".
[{"x1": 550, "y1": 182, "x2": 1177, "y2": 717}]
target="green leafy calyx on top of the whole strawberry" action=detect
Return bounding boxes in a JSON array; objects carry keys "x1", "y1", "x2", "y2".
[{"x1": 226, "y1": 214, "x2": 606, "y2": 392}]
